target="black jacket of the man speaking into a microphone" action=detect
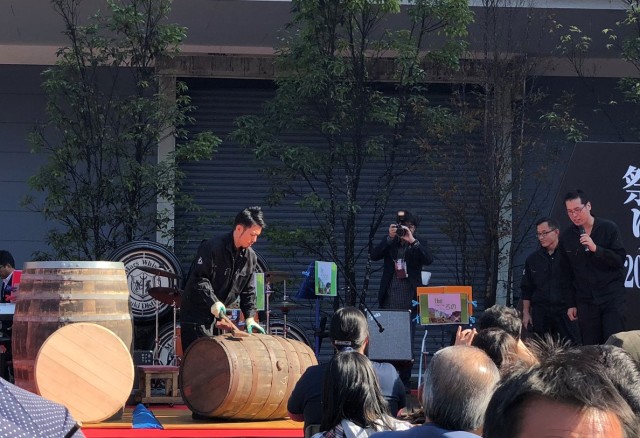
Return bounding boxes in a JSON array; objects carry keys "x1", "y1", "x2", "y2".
[{"x1": 559, "y1": 217, "x2": 627, "y2": 307}]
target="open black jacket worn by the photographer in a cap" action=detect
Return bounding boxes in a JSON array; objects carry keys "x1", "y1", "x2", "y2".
[{"x1": 370, "y1": 236, "x2": 433, "y2": 305}]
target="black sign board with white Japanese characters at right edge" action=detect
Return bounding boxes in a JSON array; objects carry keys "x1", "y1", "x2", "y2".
[{"x1": 552, "y1": 142, "x2": 640, "y2": 330}]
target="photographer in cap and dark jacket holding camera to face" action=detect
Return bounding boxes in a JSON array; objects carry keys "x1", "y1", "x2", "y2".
[{"x1": 370, "y1": 210, "x2": 433, "y2": 388}]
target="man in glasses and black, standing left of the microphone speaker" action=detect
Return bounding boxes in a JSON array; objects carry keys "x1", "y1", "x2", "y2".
[{"x1": 520, "y1": 217, "x2": 579, "y2": 343}]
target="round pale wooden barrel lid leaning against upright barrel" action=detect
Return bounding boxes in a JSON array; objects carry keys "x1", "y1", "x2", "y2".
[{"x1": 35, "y1": 322, "x2": 134, "y2": 423}]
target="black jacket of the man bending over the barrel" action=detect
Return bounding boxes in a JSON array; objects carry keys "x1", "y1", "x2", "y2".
[{"x1": 180, "y1": 233, "x2": 257, "y2": 325}]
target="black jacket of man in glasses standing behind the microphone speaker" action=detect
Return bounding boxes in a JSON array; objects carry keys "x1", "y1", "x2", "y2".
[{"x1": 520, "y1": 247, "x2": 570, "y2": 311}]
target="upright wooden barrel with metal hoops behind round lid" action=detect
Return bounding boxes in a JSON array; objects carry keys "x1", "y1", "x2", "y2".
[{"x1": 11, "y1": 261, "x2": 133, "y2": 392}]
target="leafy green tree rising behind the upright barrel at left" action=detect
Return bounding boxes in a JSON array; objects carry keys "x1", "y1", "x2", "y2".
[{"x1": 25, "y1": 0, "x2": 220, "y2": 260}]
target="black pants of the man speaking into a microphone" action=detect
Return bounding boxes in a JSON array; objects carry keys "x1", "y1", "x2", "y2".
[{"x1": 578, "y1": 298, "x2": 625, "y2": 345}]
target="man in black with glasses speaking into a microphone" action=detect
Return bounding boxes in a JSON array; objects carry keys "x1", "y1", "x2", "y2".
[{"x1": 560, "y1": 189, "x2": 626, "y2": 345}]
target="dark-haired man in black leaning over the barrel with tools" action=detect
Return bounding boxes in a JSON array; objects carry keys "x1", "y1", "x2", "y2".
[{"x1": 180, "y1": 207, "x2": 266, "y2": 351}]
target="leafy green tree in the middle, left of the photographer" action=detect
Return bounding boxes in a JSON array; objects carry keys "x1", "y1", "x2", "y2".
[{"x1": 231, "y1": 0, "x2": 472, "y2": 304}]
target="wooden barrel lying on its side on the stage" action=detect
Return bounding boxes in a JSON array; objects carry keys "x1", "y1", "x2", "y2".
[{"x1": 179, "y1": 334, "x2": 318, "y2": 420}]
